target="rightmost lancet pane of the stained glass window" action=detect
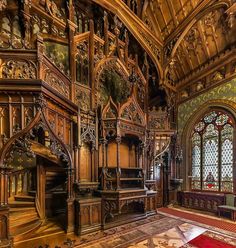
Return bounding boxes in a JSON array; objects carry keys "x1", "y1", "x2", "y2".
[{"x1": 221, "y1": 124, "x2": 233, "y2": 192}]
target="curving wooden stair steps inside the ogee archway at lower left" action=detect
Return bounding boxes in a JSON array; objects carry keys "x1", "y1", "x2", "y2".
[{"x1": 9, "y1": 195, "x2": 42, "y2": 242}]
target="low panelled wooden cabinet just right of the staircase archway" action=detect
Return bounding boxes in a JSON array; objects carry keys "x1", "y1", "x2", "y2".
[{"x1": 75, "y1": 197, "x2": 101, "y2": 235}]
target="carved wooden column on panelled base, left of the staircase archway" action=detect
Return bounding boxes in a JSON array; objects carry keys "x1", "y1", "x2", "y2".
[{"x1": 0, "y1": 167, "x2": 11, "y2": 247}]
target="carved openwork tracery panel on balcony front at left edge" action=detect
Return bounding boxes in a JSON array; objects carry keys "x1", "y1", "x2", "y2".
[{"x1": 0, "y1": 60, "x2": 37, "y2": 79}]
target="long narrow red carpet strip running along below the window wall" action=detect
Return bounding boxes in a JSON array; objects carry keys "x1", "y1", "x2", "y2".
[{"x1": 158, "y1": 208, "x2": 236, "y2": 233}]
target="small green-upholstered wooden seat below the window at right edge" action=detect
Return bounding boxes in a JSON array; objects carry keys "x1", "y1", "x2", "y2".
[{"x1": 217, "y1": 194, "x2": 236, "y2": 221}]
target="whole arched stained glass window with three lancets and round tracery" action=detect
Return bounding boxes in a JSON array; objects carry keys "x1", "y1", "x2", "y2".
[{"x1": 191, "y1": 111, "x2": 234, "y2": 192}]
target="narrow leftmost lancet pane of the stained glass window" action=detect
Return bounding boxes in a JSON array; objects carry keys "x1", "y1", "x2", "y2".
[{"x1": 192, "y1": 133, "x2": 201, "y2": 189}]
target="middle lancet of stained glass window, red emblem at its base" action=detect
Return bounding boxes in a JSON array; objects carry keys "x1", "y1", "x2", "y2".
[{"x1": 202, "y1": 124, "x2": 219, "y2": 190}]
